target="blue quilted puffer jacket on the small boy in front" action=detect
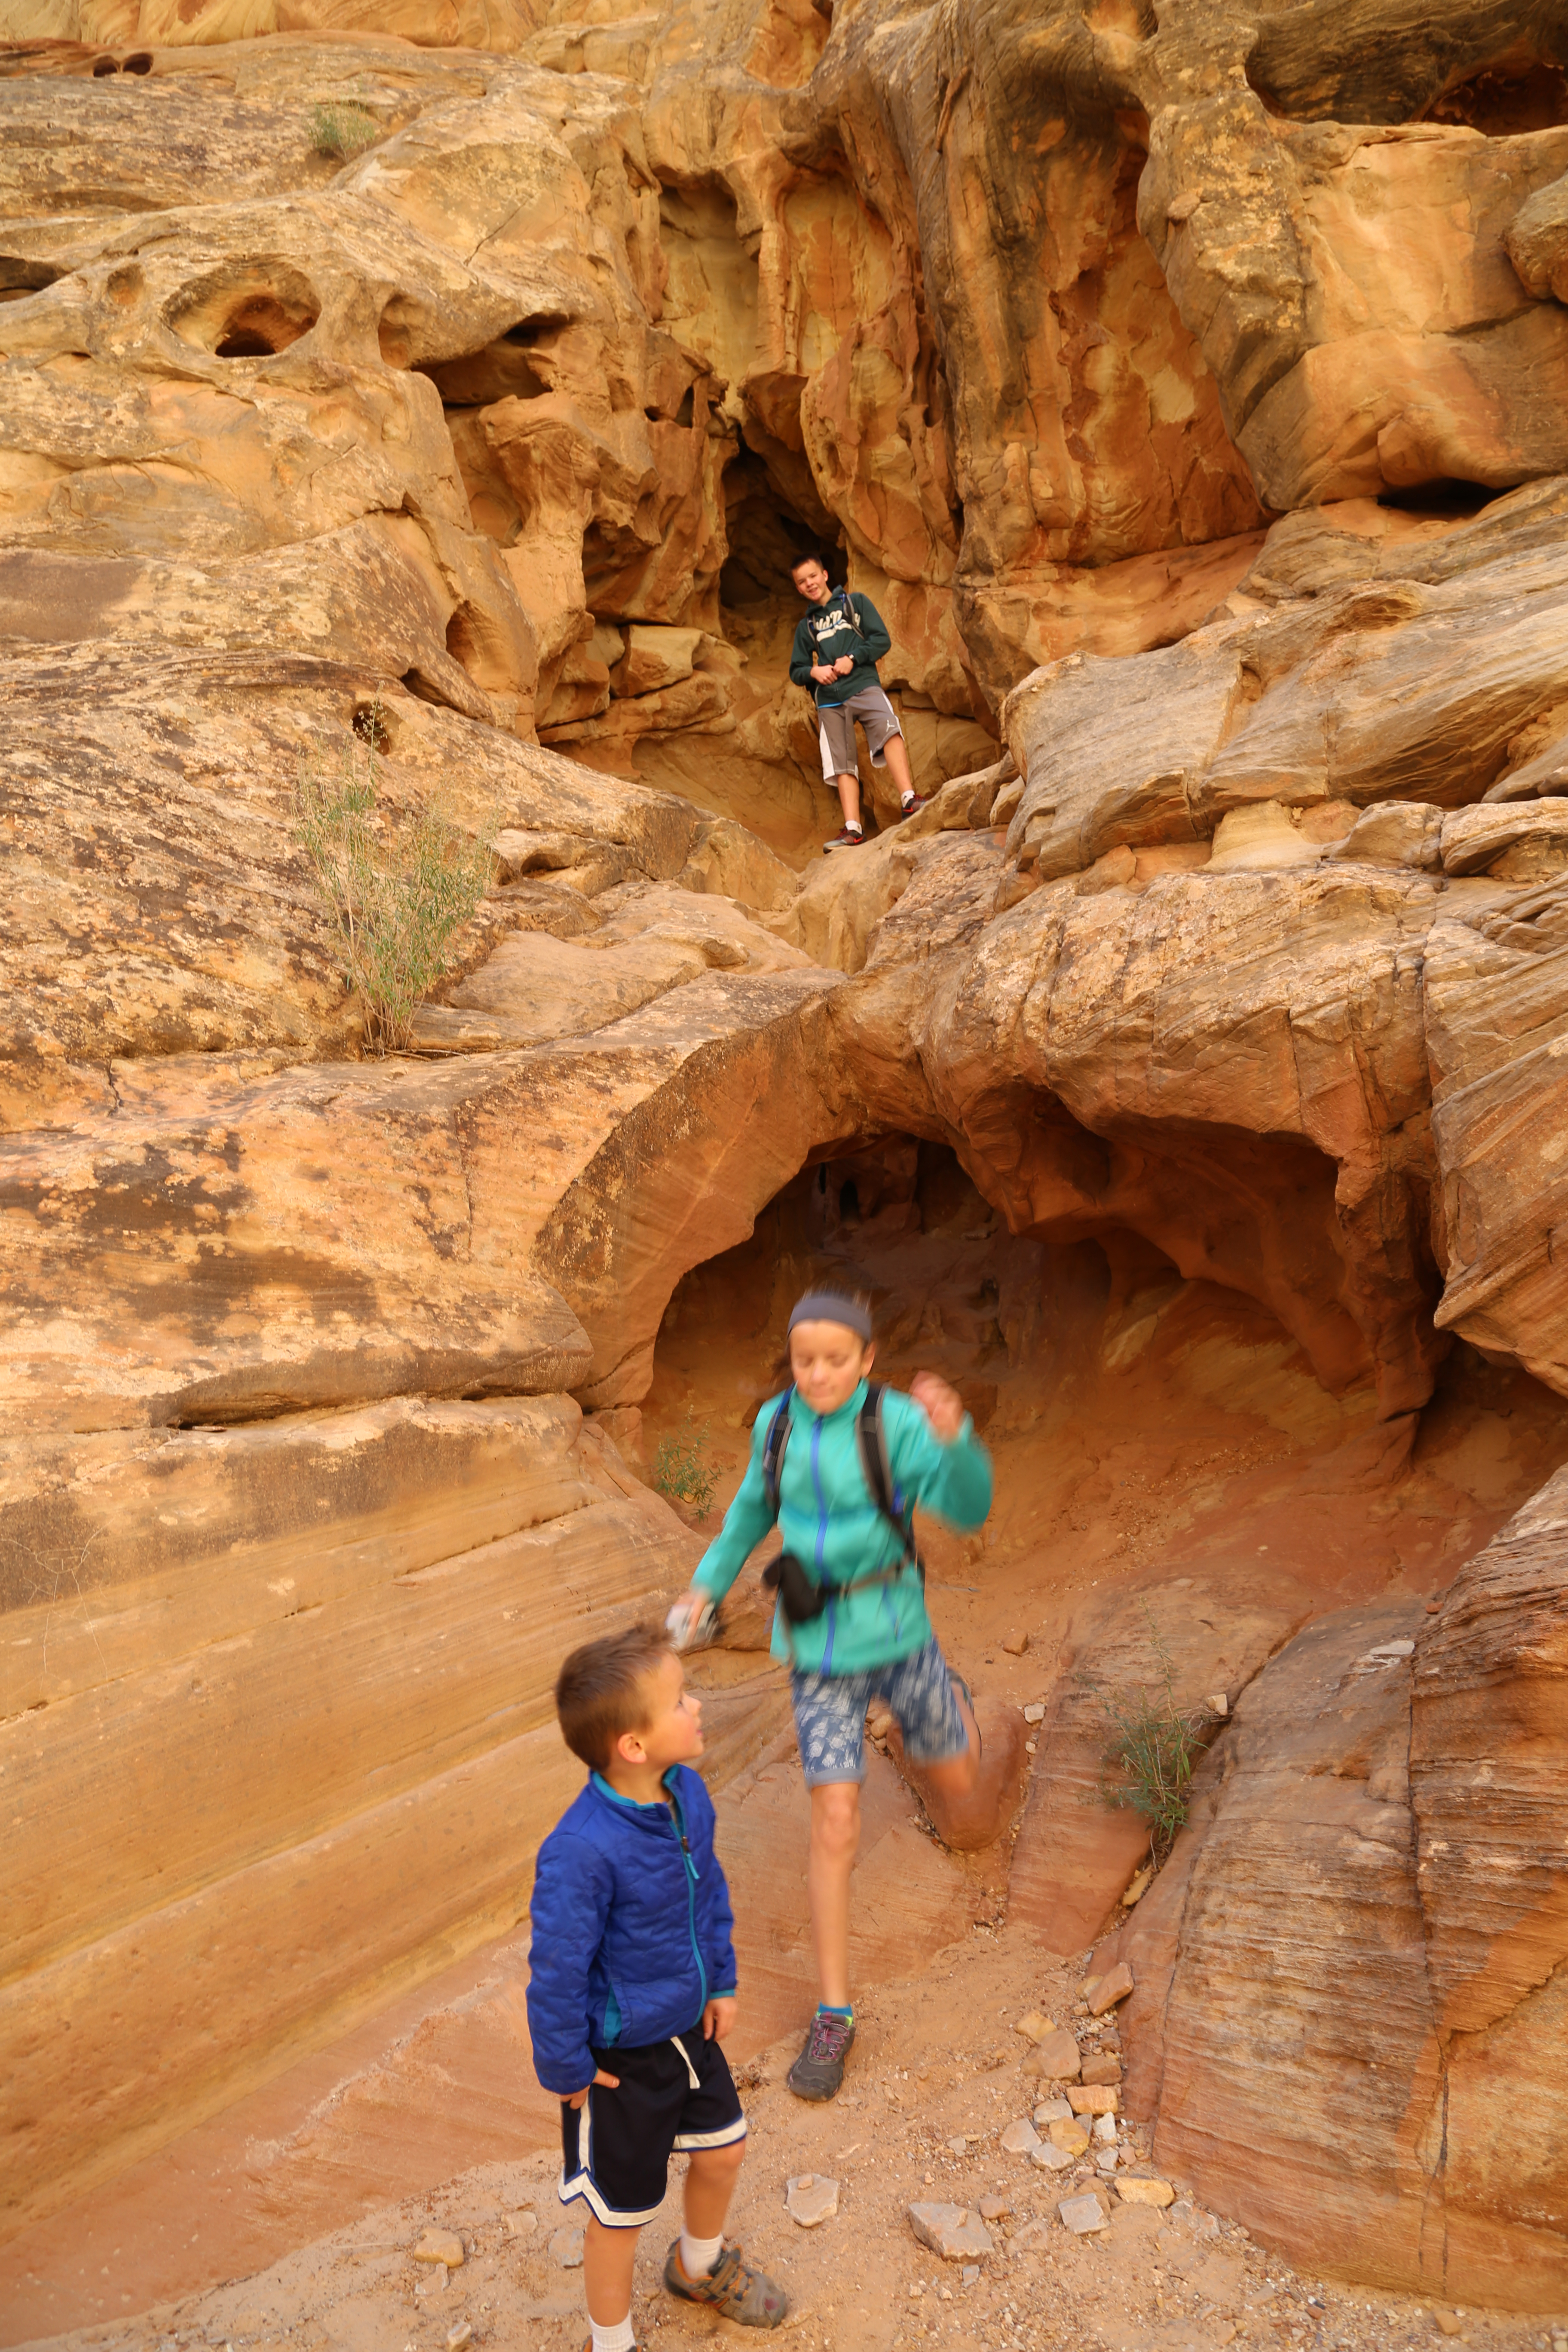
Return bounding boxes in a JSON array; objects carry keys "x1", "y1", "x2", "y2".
[{"x1": 529, "y1": 1764, "x2": 736, "y2": 2098}]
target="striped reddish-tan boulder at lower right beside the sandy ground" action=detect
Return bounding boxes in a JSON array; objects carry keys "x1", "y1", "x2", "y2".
[{"x1": 1121, "y1": 1475, "x2": 1568, "y2": 2310}]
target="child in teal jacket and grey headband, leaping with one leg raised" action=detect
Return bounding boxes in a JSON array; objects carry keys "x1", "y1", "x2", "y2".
[{"x1": 668, "y1": 1291, "x2": 992, "y2": 2098}]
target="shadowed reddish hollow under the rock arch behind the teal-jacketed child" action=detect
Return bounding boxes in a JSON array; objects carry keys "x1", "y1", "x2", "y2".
[{"x1": 618, "y1": 1136, "x2": 1568, "y2": 1637}]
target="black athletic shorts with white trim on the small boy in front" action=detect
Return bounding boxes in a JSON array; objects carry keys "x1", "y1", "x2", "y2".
[{"x1": 557, "y1": 2018, "x2": 745, "y2": 2230}]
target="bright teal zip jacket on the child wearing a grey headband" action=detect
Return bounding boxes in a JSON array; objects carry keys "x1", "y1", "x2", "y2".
[{"x1": 693, "y1": 1381, "x2": 992, "y2": 1675}]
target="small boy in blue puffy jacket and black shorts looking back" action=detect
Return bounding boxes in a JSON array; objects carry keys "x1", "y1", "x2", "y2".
[{"x1": 529, "y1": 1625, "x2": 790, "y2": 2352}]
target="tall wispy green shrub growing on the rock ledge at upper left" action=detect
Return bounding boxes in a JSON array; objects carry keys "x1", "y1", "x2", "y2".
[{"x1": 294, "y1": 703, "x2": 496, "y2": 1054}]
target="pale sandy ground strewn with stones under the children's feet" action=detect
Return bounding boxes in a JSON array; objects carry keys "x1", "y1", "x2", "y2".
[{"x1": 21, "y1": 1929, "x2": 1568, "y2": 2352}]
